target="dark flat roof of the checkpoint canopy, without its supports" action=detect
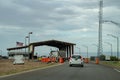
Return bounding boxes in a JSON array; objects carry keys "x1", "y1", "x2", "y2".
[{"x1": 7, "y1": 40, "x2": 76, "y2": 50}]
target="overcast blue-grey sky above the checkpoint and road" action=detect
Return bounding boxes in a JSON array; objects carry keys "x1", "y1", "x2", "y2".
[{"x1": 0, "y1": 0, "x2": 120, "y2": 54}]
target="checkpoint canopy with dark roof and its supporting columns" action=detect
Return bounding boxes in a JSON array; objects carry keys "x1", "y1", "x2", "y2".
[{"x1": 7, "y1": 40, "x2": 76, "y2": 59}]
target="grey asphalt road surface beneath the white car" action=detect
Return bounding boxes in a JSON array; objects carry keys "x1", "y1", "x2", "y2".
[{"x1": 0, "y1": 63, "x2": 120, "y2": 80}]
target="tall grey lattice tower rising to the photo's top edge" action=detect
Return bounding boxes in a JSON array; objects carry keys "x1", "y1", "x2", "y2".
[{"x1": 97, "y1": 0, "x2": 103, "y2": 57}]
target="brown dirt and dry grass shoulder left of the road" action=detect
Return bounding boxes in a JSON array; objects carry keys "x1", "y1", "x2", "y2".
[{"x1": 0, "y1": 60, "x2": 58, "y2": 76}]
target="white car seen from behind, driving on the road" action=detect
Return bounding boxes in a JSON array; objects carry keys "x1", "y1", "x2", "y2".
[{"x1": 69, "y1": 54, "x2": 84, "y2": 67}]
